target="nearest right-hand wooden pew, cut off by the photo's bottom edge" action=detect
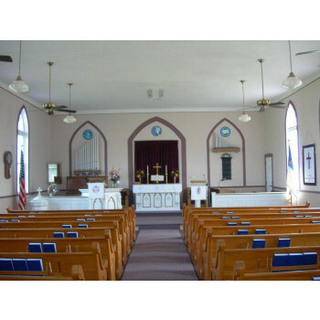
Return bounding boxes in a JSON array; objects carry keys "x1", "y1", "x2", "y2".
[{"x1": 233, "y1": 261, "x2": 320, "y2": 281}]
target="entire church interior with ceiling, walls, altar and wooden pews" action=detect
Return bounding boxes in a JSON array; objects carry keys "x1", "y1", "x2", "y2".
[{"x1": 0, "y1": 35, "x2": 320, "y2": 318}]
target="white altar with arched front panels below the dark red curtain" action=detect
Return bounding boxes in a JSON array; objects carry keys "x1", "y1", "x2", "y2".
[{"x1": 132, "y1": 183, "x2": 182, "y2": 212}]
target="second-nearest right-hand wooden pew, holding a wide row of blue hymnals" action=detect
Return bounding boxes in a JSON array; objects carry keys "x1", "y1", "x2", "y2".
[{"x1": 209, "y1": 240, "x2": 320, "y2": 280}]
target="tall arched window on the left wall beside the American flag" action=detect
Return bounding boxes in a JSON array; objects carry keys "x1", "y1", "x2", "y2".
[{"x1": 16, "y1": 108, "x2": 29, "y2": 193}]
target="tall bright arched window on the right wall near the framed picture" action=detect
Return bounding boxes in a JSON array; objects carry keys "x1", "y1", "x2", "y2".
[{"x1": 286, "y1": 104, "x2": 300, "y2": 198}]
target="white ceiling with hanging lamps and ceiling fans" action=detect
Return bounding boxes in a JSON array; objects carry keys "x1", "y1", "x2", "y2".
[{"x1": 0, "y1": 41, "x2": 320, "y2": 114}]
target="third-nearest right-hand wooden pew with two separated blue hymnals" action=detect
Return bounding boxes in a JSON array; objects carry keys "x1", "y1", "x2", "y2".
[{"x1": 200, "y1": 231, "x2": 320, "y2": 279}]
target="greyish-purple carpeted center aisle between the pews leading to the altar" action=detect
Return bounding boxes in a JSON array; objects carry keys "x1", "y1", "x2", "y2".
[{"x1": 122, "y1": 212, "x2": 198, "y2": 280}]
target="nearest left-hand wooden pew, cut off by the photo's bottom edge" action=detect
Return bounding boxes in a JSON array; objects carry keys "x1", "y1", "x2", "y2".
[{"x1": 0, "y1": 265, "x2": 86, "y2": 281}]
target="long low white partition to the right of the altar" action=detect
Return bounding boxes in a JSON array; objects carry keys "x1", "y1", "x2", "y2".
[{"x1": 211, "y1": 192, "x2": 288, "y2": 207}]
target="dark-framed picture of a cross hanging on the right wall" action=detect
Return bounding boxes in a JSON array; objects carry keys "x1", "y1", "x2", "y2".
[{"x1": 302, "y1": 144, "x2": 317, "y2": 186}]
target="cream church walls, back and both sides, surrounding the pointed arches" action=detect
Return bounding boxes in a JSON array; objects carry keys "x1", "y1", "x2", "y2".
[{"x1": 0, "y1": 80, "x2": 320, "y2": 212}]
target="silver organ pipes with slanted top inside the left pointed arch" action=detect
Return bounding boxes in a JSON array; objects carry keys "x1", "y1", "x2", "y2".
[{"x1": 75, "y1": 135, "x2": 100, "y2": 171}]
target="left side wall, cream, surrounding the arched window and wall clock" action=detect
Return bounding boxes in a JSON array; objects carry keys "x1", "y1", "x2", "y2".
[{"x1": 0, "y1": 88, "x2": 51, "y2": 212}]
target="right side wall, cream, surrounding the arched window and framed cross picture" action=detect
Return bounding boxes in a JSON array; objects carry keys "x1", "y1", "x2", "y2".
[{"x1": 264, "y1": 80, "x2": 320, "y2": 206}]
